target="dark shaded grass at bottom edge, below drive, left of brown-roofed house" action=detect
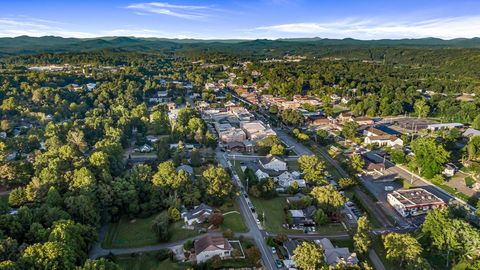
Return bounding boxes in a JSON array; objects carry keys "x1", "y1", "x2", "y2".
[{"x1": 116, "y1": 252, "x2": 188, "y2": 270}]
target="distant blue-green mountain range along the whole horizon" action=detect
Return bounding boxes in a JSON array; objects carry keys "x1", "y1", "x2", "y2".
[{"x1": 0, "y1": 36, "x2": 480, "y2": 56}]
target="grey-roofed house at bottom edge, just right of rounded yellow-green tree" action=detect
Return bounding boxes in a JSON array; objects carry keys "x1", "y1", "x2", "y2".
[{"x1": 315, "y1": 238, "x2": 359, "y2": 267}]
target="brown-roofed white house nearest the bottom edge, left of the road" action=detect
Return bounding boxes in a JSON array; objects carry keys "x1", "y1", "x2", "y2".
[{"x1": 194, "y1": 235, "x2": 233, "y2": 263}]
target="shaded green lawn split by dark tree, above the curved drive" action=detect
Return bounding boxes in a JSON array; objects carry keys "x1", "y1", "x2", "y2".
[{"x1": 102, "y1": 215, "x2": 197, "y2": 248}]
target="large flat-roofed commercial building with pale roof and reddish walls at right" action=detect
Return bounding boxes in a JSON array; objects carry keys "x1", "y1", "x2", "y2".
[{"x1": 387, "y1": 188, "x2": 446, "y2": 217}]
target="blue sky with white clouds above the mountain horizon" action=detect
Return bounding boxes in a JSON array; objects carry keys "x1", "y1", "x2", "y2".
[{"x1": 0, "y1": 0, "x2": 480, "y2": 39}]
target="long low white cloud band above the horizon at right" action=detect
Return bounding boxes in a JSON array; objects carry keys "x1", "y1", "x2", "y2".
[{"x1": 253, "y1": 16, "x2": 480, "y2": 39}]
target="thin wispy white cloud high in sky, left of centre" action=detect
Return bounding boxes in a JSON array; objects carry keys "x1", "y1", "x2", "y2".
[{"x1": 126, "y1": 2, "x2": 212, "y2": 20}]
